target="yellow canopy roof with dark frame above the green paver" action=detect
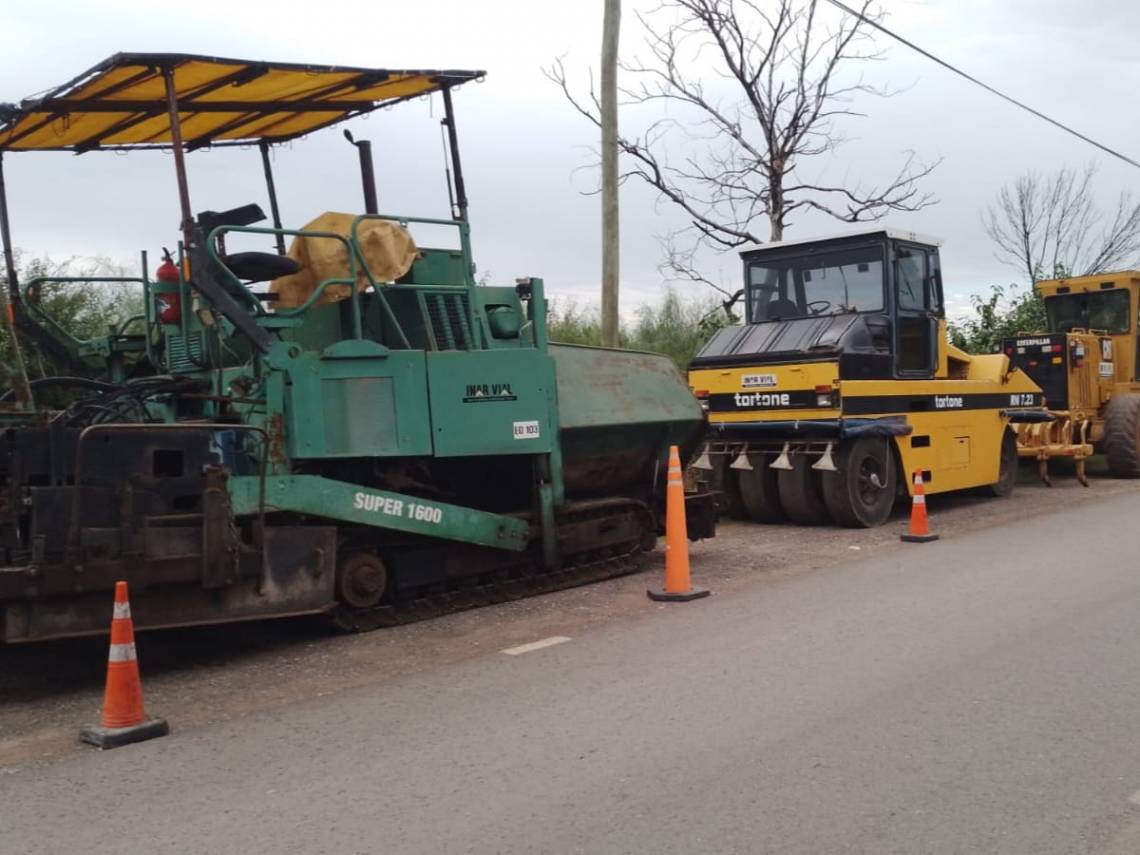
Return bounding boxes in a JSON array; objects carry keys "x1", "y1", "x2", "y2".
[{"x1": 0, "y1": 54, "x2": 483, "y2": 153}]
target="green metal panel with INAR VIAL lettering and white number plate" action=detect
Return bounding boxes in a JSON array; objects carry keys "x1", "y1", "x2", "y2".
[{"x1": 426, "y1": 350, "x2": 556, "y2": 457}]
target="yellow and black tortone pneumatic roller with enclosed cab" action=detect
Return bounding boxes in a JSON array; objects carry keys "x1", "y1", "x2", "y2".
[{"x1": 689, "y1": 229, "x2": 1048, "y2": 526}]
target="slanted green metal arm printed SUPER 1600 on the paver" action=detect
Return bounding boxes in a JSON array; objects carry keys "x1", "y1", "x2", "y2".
[{"x1": 228, "y1": 475, "x2": 530, "y2": 552}]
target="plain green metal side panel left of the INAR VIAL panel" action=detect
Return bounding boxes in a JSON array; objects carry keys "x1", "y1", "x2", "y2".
[{"x1": 285, "y1": 342, "x2": 432, "y2": 458}]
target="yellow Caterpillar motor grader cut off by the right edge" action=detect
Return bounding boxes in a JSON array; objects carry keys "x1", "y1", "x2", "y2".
[{"x1": 1002, "y1": 270, "x2": 1140, "y2": 487}]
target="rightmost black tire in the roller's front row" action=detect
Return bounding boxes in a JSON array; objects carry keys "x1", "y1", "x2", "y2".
[{"x1": 823, "y1": 437, "x2": 898, "y2": 529}]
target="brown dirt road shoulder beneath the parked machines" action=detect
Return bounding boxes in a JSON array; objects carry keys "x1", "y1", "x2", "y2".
[{"x1": 0, "y1": 466, "x2": 1140, "y2": 774}]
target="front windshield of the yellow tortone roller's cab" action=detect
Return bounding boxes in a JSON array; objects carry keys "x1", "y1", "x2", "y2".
[{"x1": 748, "y1": 246, "x2": 884, "y2": 324}]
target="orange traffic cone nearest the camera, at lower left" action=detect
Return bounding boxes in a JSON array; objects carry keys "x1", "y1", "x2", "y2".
[{"x1": 79, "y1": 581, "x2": 170, "y2": 748}]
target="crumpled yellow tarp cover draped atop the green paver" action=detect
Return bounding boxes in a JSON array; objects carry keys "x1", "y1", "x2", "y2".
[{"x1": 269, "y1": 211, "x2": 418, "y2": 309}]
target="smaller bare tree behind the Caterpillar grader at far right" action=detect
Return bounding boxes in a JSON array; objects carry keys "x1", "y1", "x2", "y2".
[{"x1": 982, "y1": 164, "x2": 1140, "y2": 283}]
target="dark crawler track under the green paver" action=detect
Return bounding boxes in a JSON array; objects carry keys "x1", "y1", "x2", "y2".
[{"x1": 331, "y1": 499, "x2": 657, "y2": 633}]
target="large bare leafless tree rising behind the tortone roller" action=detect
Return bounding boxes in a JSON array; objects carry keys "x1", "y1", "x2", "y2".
[{"x1": 547, "y1": 0, "x2": 937, "y2": 284}]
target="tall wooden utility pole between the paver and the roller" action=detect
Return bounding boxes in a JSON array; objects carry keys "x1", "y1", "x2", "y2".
[{"x1": 601, "y1": 0, "x2": 621, "y2": 348}]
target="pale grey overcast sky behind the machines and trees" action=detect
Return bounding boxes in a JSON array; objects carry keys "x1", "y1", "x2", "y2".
[{"x1": 0, "y1": 0, "x2": 1140, "y2": 314}]
